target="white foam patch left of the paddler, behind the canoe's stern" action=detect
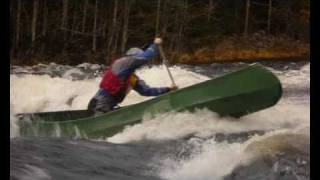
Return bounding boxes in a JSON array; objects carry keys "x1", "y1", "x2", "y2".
[{"x1": 10, "y1": 75, "x2": 98, "y2": 113}]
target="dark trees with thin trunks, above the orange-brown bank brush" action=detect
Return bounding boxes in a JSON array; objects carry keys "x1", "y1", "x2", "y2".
[{"x1": 10, "y1": 0, "x2": 310, "y2": 63}]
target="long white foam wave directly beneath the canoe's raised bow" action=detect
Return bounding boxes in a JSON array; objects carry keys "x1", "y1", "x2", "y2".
[{"x1": 107, "y1": 99, "x2": 310, "y2": 143}]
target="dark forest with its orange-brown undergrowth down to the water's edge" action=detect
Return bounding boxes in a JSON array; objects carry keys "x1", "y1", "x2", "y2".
[{"x1": 10, "y1": 0, "x2": 310, "y2": 65}]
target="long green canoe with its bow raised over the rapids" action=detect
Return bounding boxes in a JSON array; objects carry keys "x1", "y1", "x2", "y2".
[{"x1": 19, "y1": 64, "x2": 282, "y2": 138}]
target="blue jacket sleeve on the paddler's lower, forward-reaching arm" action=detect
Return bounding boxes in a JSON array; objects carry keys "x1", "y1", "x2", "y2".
[{"x1": 133, "y1": 79, "x2": 170, "y2": 96}]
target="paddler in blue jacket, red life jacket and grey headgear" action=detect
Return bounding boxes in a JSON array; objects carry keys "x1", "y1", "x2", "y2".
[{"x1": 88, "y1": 38, "x2": 177, "y2": 114}]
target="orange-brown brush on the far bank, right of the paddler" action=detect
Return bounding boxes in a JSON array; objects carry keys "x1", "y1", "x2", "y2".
[{"x1": 170, "y1": 31, "x2": 310, "y2": 64}]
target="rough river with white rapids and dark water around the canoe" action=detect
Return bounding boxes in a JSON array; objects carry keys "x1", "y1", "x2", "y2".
[{"x1": 10, "y1": 61, "x2": 310, "y2": 180}]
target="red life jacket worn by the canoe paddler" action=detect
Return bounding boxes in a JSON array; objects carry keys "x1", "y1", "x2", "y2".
[{"x1": 100, "y1": 69, "x2": 137, "y2": 102}]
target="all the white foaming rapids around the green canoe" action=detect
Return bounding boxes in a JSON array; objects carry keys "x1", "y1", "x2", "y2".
[{"x1": 10, "y1": 64, "x2": 310, "y2": 180}]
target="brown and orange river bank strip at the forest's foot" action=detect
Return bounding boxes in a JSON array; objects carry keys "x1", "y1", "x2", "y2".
[{"x1": 10, "y1": 31, "x2": 310, "y2": 66}]
